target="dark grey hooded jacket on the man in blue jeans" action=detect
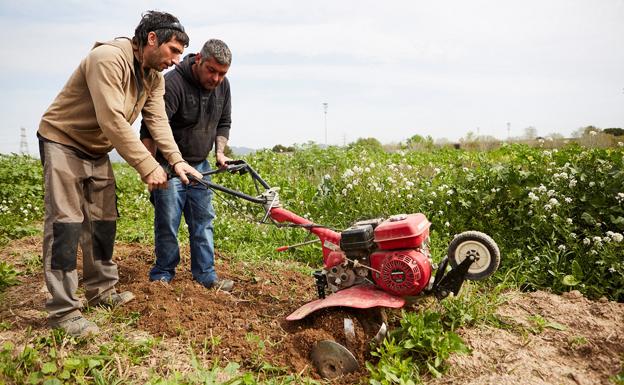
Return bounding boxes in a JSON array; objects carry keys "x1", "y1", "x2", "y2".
[{"x1": 141, "y1": 54, "x2": 232, "y2": 164}]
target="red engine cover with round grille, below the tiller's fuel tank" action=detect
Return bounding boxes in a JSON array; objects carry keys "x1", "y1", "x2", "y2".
[{"x1": 370, "y1": 249, "x2": 431, "y2": 297}]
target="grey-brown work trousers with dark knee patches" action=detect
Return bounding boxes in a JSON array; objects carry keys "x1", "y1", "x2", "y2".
[{"x1": 40, "y1": 141, "x2": 119, "y2": 323}]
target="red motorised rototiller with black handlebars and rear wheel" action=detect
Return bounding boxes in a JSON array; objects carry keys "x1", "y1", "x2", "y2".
[{"x1": 191, "y1": 160, "x2": 500, "y2": 378}]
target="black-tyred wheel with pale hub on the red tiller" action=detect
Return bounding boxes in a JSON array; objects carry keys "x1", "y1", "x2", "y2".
[{"x1": 448, "y1": 231, "x2": 500, "y2": 281}]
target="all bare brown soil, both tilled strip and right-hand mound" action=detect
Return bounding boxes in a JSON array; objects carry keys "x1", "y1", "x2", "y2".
[{"x1": 0, "y1": 237, "x2": 624, "y2": 385}]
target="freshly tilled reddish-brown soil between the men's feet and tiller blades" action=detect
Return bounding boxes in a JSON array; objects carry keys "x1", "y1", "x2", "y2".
[{"x1": 117, "y1": 245, "x2": 376, "y2": 373}]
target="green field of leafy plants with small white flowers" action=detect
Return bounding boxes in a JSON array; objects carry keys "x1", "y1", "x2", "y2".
[{"x1": 0, "y1": 142, "x2": 624, "y2": 384}]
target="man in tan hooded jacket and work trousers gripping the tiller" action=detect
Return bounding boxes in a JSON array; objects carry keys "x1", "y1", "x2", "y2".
[{"x1": 37, "y1": 11, "x2": 202, "y2": 336}]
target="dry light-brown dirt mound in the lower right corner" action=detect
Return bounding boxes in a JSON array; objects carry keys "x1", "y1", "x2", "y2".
[{"x1": 431, "y1": 291, "x2": 624, "y2": 385}]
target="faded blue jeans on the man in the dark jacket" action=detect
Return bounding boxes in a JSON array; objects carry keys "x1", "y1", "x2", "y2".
[{"x1": 149, "y1": 160, "x2": 217, "y2": 286}]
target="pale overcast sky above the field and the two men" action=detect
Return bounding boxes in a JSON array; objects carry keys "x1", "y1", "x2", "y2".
[{"x1": 0, "y1": 0, "x2": 624, "y2": 153}]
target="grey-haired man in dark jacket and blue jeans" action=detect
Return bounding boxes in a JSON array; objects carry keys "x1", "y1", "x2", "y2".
[{"x1": 141, "y1": 39, "x2": 234, "y2": 291}]
